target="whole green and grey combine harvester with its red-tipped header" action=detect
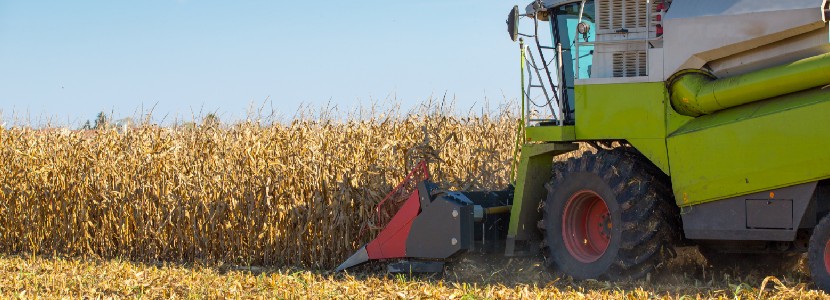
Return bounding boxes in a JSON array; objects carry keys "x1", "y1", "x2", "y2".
[{"x1": 338, "y1": 0, "x2": 830, "y2": 291}]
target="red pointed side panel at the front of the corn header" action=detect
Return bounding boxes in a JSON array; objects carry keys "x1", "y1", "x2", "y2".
[{"x1": 366, "y1": 190, "x2": 421, "y2": 259}]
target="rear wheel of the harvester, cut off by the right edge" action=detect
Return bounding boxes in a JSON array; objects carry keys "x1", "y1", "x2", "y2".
[{"x1": 807, "y1": 215, "x2": 830, "y2": 293}]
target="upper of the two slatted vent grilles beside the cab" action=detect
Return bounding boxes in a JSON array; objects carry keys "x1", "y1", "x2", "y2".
[{"x1": 596, "y1": 0, "x2": 648, "y2": 30}]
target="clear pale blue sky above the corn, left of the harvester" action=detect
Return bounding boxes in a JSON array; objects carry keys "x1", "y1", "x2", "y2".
[{"x1": 0, "y1": 0, "x2": 524, "y2": 126}]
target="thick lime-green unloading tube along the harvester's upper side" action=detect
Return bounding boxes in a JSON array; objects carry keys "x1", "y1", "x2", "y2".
[{"x1": 668, "y1": 53, "x2": 830, "y2": 117}]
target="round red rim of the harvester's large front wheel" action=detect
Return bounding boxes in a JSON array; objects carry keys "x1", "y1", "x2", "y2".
[{"x1": 562, "y1": 190, "x2": 616, "y2": 263}]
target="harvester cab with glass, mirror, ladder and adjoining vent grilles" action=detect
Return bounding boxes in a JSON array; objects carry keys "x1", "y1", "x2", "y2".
[{"x1": 507, "y1": 0, "x2": 671, "y2": 126}]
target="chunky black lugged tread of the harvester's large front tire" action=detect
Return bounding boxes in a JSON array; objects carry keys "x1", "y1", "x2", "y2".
[{"x1": 539, "y1": 146, "x2": 681, "y2": 280}]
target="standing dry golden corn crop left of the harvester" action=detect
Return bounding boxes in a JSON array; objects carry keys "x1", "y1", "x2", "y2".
[{"x1": 0, "y1": 109, "x2": 517, "y2": 269}]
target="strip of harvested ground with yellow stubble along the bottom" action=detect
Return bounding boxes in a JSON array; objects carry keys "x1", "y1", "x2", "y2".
[{"x1": 0, "y1": 252, "x2": 827, "y2": 299}]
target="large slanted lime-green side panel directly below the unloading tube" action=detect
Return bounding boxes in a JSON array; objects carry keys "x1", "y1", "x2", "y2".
[{"x1": 668, "y1": 85, "x2": 830, "y2": 206}]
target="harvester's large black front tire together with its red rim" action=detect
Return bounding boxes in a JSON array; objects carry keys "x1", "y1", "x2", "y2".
[{"x1": 539, "y1": 146, "x2": 681, "y2": 280}]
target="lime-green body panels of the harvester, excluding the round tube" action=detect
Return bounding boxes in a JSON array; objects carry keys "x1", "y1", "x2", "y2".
[{"x1": 508, "y1": 82, "x2": 830, "y2": 240}]
